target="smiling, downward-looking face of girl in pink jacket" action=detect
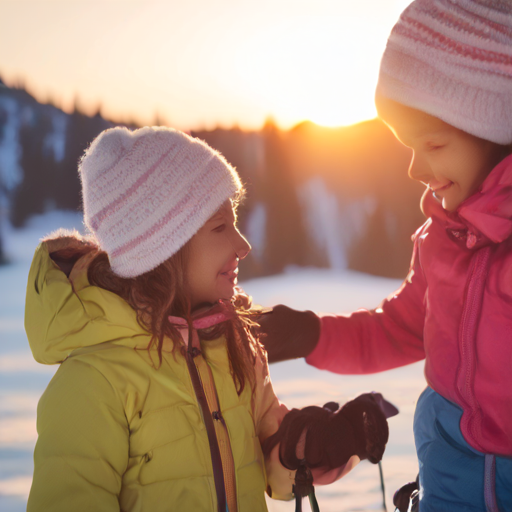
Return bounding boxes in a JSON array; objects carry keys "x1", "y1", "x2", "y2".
[{"x1": 376, "y1": 98, "x2": 505, "y2": 211}]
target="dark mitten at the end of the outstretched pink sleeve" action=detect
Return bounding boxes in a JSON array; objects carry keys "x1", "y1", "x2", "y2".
[{"x1": 257, "y1": 305, "x2": 320, "y2": 363}]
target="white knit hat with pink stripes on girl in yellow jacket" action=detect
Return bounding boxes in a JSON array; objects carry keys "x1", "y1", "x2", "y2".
[{"x1": 79, "y1": 126, "x2": 242, "y2": 277}]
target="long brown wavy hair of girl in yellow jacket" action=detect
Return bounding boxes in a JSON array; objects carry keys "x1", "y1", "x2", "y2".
[{"x1": 88, "y1": 244, "x2": 265, "y2": 395}]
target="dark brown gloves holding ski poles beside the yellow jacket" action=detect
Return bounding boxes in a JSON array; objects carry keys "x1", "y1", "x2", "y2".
[{"x1": 263, "y1": 393, "x2": 398, "y2": 470}]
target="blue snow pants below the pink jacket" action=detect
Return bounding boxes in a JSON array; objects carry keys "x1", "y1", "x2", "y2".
[{"x1": 414, "y1": 387, "x2": 512, "y2": 512}]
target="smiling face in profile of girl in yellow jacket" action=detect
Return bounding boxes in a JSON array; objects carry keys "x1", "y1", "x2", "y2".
[{"x1": 187, "y1": 200, "x2": 251, "y2": 307}]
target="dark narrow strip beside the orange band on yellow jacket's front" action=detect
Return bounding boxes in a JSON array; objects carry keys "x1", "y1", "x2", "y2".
[{"x1": 186, "y1": 348, "x2": 226, "y2": 512}]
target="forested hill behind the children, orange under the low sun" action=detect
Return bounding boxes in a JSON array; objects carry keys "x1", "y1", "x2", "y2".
[{"x1": 0, "y1": 81, "x2": 423, "y2": 278}]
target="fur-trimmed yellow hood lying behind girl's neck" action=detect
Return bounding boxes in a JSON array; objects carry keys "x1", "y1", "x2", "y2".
[{"x1": 25, "y1": 232, "x2": 150, "y2": 364}]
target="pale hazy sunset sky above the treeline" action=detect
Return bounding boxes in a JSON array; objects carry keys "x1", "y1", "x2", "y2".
[{"x1": 0, "y1": 0, "x2": 409, "y2": 129}]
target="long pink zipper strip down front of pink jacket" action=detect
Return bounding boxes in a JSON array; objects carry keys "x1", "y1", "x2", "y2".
[{"x1": 457, "y1": 246, "x2": 491, "y2": 446}]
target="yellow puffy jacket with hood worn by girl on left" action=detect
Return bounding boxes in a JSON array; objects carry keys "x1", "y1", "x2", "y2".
[{"x1": 25, "y1": 238, "x2": 294, "y2": 512}]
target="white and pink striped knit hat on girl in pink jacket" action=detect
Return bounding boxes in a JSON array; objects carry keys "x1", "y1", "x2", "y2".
[{"x1": 376, "y1": 0, "x2": 512, "y2": 144}]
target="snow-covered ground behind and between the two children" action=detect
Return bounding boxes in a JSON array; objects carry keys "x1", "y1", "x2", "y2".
[{"x1": 0, "y1": 212, "x2": 425, "y2": 512}]
